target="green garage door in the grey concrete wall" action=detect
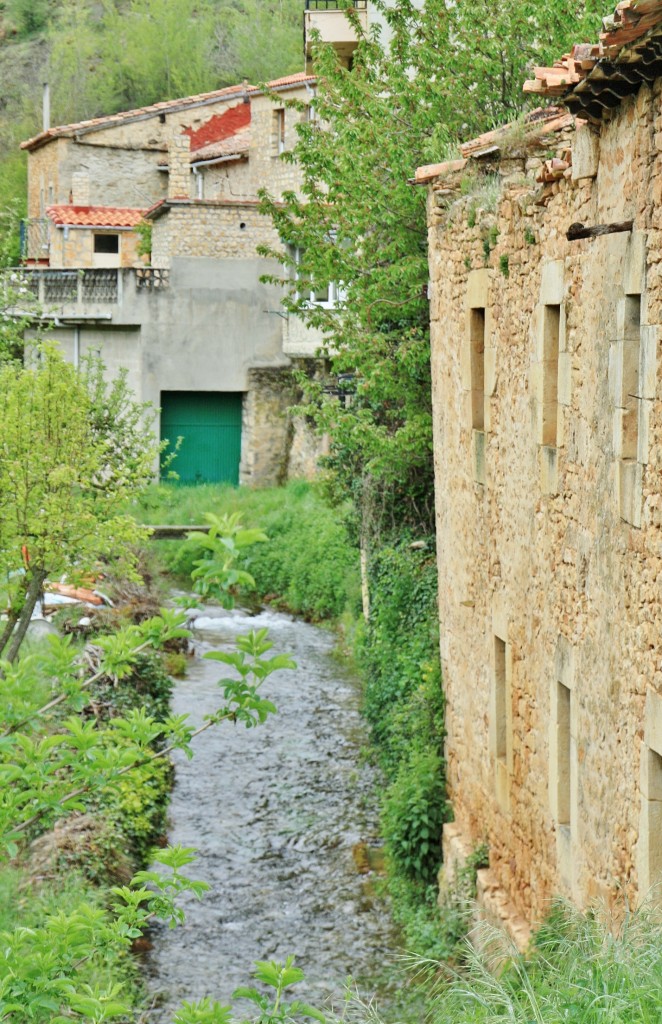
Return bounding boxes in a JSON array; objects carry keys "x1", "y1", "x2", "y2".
[{"x1": 161, "y1": 391, "x2": 242, "y2": 483}]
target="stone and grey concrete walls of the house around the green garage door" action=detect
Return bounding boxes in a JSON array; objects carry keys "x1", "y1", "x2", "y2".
[{"x1": 24, "y1": 87, "x2": 325, "y2": 483}]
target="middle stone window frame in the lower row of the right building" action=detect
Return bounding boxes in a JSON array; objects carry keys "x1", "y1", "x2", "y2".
[{"x1": 549, "y1": 636, "x2": 579, "y2": 893}]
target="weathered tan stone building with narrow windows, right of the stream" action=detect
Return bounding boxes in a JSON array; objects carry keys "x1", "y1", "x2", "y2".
[{"x1": 416, "y1": 0, "x2": 662, "y2": 945}]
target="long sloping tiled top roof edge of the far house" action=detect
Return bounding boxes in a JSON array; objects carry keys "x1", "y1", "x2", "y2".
[{"x1": 20, "y1": 72, "x2": 316, "y2": 150}]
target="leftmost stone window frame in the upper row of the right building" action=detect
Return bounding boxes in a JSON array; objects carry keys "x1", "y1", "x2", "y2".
[{"x1": 461, "y1": 268, "x2": 496, "y2": 486}]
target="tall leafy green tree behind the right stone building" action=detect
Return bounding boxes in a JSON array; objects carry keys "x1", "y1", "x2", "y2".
[{"x1": 262, "y1": 0, "x2": 597, "y2": 535}]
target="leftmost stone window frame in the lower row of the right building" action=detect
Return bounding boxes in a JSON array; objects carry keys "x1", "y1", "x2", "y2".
[{"x1": 490, "y1": 598, "x2": 513, "y2": 813}]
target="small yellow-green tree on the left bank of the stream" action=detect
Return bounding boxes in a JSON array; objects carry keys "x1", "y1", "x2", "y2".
[{"x1": 0, "y1": 343, "x2": 159, "y2": 662}]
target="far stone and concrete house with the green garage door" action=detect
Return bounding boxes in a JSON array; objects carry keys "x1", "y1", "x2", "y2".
[{"x1": 23, "y1": 74, "x2": 329, "y2": 483}]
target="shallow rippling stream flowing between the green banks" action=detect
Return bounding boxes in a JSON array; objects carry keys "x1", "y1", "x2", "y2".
[{"x1": 146, "y1": 608, "x2": 397, "y2": 1024}]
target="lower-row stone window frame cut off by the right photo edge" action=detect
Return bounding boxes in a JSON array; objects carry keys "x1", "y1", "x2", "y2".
[{"x1": 636, "y1": 689, "x2": 662, "y2": 903}]
